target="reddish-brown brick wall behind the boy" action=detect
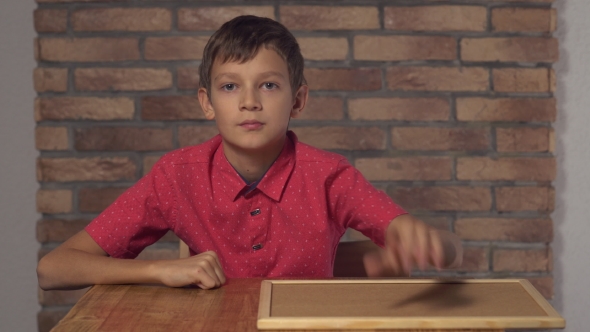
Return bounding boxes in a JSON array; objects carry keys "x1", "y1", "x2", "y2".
[{"x1": 34, "y1": 0, "x2": 558, "y2": 331}]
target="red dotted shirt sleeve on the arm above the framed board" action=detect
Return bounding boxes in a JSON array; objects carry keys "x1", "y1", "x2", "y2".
[{"x1": 328, "y1": 159, "x2": 407, "y2": 247}]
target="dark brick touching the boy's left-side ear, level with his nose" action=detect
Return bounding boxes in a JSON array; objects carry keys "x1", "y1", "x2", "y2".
[{"x1": 141, "y1": 96, "x2": 205, "y2": 121}]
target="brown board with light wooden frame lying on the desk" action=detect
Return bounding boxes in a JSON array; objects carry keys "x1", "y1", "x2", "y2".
[{"x1": 257, "y1": 279, "x2": 565, "y2": 330}]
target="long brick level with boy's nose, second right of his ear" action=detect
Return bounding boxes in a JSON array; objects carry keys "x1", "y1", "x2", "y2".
[{"x1": 348, "y1": 98, "x2": 451, "y2": 121}]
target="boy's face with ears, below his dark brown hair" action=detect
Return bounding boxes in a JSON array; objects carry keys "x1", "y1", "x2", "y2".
[{"x1": 199, "y1": 46, "x2": 308, "y2": 154}]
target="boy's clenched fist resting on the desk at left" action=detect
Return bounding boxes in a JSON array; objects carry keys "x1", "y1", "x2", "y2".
[{"x1": 155, "y1": 251, "x2": 225, "y2": 289}]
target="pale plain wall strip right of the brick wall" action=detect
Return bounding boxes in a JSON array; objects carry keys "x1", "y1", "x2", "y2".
[{"x1": 553, "y1": 0, "x2": 590, "y2": 332}]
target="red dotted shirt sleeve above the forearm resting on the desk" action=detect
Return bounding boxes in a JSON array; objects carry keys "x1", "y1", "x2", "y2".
[{"x1": 85, "y1": 163, "x2": 176, "y2": 258}]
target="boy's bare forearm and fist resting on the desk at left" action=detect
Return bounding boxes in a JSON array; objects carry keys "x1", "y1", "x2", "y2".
[{"x1": 37, "y1": 230, "x2": 225, "y2": 290}]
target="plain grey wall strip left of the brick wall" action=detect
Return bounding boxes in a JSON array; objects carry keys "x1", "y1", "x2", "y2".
[{"x1": 0, "y1": 0, "x2": 39, "y2": 331}]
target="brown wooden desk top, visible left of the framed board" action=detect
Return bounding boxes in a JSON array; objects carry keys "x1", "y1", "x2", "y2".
[{"x1": 52, "y1": 279, "x2": 503, "y2": 332}]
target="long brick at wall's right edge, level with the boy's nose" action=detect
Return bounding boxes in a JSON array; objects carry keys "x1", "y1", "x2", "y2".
[{"x1": 457, "y1": 97, "x2": 557, "y2": 122}]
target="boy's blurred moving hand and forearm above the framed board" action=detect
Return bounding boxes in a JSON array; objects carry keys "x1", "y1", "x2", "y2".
[{"x1": 364, "y1": 214, "x2": 463, "y2": 277}]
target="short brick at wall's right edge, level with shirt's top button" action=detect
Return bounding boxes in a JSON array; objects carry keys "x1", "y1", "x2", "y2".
[{"x1": 495, "y1": 187, "x2": 555, "y2": 212}]
